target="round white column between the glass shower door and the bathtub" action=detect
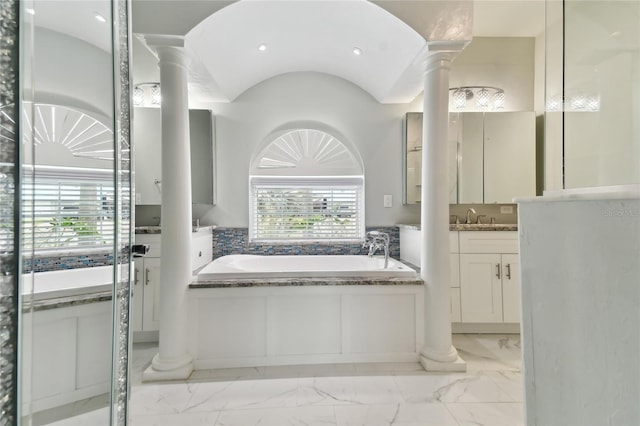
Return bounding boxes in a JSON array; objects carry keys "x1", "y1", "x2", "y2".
[{"x1": 144, "y1": 36, "x2": 193, "y2": 380}]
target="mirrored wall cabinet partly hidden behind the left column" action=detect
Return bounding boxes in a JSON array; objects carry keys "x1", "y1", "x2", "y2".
[{"x1": 133, "y1": 108, "x2": 215, "y2": 205}]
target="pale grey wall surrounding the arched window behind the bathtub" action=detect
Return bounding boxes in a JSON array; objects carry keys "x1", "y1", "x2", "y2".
[{"x1": 200, "y1": 72, "x2": 421, "y2": 227}]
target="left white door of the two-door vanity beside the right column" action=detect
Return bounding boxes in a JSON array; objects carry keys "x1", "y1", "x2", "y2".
[{"x1": 460, "y1": 254, "x2": 502, "y2": 322}]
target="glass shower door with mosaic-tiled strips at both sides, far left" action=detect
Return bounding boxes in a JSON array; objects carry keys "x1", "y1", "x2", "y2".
[{"x1": 0, "y1": 0, "x2": 133, "y2": 425}]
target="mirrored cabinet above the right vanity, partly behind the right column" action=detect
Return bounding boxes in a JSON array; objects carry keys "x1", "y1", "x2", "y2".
[{"x1": 402, "y1": 112, "x2": 536, "y2": 204}]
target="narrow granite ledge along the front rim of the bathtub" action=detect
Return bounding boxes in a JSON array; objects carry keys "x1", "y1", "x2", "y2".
[{"x1": 189, "y1": 277, "x2": 424, "y2": 289}]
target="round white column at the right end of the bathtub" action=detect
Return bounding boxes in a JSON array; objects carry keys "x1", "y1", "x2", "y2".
[{"x1": 420, "y1": 42, "x2": 467, "y2": 371}]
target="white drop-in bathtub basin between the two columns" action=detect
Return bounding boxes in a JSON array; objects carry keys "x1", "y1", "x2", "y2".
[{"x1": 197, "y1": 254, "x2": 417, "y2": 281}]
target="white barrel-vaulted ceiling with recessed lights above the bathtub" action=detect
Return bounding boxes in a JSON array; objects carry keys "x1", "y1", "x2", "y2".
[{"x1": 186, "y1": 1, "x2": 425, "y2": 102}]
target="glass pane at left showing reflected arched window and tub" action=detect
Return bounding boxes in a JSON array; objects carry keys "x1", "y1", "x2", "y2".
[{"x1": 21, "y1": 0, "x2": 124, "y2": 425}]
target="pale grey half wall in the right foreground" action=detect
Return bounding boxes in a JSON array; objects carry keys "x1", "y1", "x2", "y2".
[{"x1": 518, "y1": 185, "x2": 640, "y2": 426}]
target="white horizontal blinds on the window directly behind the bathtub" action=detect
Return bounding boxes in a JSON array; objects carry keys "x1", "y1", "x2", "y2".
[{"x1": 251, "y1": 177, "x2": 364, "y2": 241}]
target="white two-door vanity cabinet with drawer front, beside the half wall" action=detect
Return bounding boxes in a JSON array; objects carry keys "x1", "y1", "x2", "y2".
[{"x1": 460, "y1": 231, "x2": 520, "y2": 323}]
